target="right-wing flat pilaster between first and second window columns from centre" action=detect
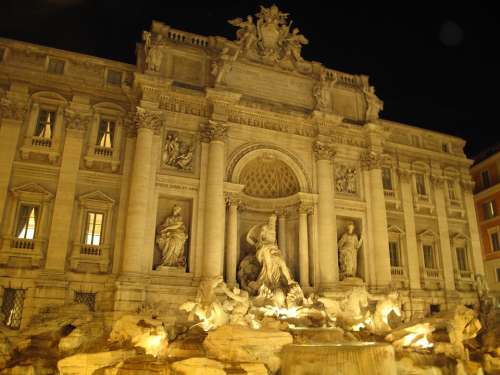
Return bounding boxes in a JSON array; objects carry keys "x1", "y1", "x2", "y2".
[{"x1": 399, "y1": 169, "x2": 421, "y2": 289}]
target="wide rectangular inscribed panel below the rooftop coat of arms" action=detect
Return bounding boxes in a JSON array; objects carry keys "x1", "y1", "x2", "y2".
[{"x1": 226, "y1": 63, "x2": 313, "y2": 108}]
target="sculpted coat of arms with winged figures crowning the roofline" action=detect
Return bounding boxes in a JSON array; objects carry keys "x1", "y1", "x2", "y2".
[{"x1": 228, "y1": 5, "x2": 309, "y2": 65}]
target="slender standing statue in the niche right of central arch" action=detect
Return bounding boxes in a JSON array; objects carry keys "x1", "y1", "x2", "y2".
[{"x1": 338, "y1": 221, "x2": 363, "y2": 279}]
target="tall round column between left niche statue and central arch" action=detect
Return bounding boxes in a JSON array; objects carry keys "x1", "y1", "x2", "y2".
[{"x1": 202, "y1": 120, "x2": 227, "y2": 277}]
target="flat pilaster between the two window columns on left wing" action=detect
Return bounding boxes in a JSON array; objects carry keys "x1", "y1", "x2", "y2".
[{"x1": 45, "y1": 110, "x2": 90, "y2": 272}]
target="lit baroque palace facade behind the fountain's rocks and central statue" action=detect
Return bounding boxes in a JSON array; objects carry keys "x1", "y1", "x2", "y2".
[{"x1": 0, "y1": 6, "x2": 484, "y2": 328}]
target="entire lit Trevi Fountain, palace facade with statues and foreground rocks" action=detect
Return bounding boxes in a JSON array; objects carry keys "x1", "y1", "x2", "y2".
[{"x1": 0, "y1": 5, "x2": 494, "y2": 375}]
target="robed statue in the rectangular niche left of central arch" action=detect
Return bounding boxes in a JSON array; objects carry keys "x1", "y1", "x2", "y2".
[{"x1": 156, "y1": 205, "x2": 188, "y2": 268}]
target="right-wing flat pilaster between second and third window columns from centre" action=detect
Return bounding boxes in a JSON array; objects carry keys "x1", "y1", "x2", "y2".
[{"x1": 431, "y1": 176, "x2": 455, "y2": 291}]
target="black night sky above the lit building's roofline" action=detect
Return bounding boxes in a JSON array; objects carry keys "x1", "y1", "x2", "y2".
[{"x1": 0, "y1": 0, "x2": 500, "y2": 157}]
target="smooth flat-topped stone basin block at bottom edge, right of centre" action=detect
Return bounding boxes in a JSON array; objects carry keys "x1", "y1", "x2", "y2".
[{"x1": 281, "y1": 342, "x2": 396, "y2": 375}]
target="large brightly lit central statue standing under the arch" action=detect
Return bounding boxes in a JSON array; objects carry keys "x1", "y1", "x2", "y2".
[{"x1": 246, "y1": 215, "x2": 304, "y2": 307}]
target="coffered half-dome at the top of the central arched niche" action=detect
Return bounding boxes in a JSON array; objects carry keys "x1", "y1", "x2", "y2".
[{"x1": 239, "y1": 153, "x2": 300, "y2": 198}]
